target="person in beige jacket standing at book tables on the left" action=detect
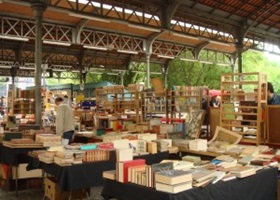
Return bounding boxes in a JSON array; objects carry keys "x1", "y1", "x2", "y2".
[{"x1": 55, "y1": 97, "x2": 75, "y2": 143}]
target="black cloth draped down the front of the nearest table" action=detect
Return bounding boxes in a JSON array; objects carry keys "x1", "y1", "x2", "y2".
[{"x1": 101, "y1": 168, "x2": 278, "y2": 200}]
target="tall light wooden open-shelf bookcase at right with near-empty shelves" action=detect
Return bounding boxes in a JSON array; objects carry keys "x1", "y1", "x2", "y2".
[{"x1": 220, "y1": 72, "x2": 267, "y2": 145}]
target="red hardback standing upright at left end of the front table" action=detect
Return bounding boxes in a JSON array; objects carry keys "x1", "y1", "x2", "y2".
[{"x1": 116, "y1": 159, "x2": 146, "y2": 183}]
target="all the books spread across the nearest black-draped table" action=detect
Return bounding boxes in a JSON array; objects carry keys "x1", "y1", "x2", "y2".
[{"x1": 103, "y1": 152, "x2": 278, "y2": 193}]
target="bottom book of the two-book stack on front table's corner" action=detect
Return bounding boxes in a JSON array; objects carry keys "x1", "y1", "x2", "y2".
[{"x1": 155, "y1": 181, "x2": 192, "y2": 194}]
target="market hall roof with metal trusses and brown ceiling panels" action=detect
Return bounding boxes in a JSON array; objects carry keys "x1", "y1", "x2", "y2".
[{"x1": 0, "y1": 0, "x2": 280, "y2": 78}]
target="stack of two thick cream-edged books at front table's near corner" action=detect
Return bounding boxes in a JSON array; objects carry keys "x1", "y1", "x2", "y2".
[{"x1": 155, "y1": 170, "x2": 192, "y2": 194}]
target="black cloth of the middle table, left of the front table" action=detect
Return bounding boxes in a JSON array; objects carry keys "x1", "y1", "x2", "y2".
[{"x1": 27, "y1": 152, "x2": 169, "y2": 191}]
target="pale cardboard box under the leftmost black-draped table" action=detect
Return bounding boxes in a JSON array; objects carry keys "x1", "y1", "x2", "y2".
[{"x1": 12, "y1": 163, "x2": 43, "y2": 179}]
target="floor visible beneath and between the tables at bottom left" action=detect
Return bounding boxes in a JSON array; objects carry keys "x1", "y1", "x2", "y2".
[{"x1": 0, "y1": 187, "x2": 103, "y2": 200}]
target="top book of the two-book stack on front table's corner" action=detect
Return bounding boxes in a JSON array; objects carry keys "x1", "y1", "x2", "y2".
[{"x1": 155, "y1": 170, "x2": 192, "y2": 185}]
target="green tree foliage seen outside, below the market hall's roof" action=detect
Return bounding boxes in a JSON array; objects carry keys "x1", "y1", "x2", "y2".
[{"x1": 44, "y1": 51, "x2": 280, "y2": 93}]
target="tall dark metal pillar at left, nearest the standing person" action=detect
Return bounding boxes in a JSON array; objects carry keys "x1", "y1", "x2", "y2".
[{"x1": 31, "y1": 0, "x2": 50, "y2": 124}]
